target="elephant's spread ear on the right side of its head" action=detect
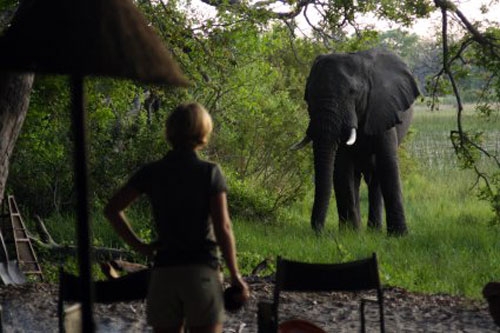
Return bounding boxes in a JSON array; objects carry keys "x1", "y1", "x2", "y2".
[{"x1": 364, "y1": 49, "x2": 420, "y2": 135}]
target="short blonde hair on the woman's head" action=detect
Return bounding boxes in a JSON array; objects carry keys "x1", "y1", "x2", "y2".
[{"x1": 165, "y1": 102, "x2": 213, "y2": 149}]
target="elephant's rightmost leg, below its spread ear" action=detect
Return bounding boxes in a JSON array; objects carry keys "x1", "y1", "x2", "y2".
[{"x1": 375, "y1": 128, "x2": 407, "y2": 235}]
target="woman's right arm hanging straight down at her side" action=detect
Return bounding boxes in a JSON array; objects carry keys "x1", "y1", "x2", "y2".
[{"x1": 210, "y1": 192, "x2": 250, "y2": 300}]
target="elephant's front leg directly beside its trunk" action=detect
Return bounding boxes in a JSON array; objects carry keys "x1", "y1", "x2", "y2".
[{"x1": 333, "y1": 148, "x2": 361, "y2": 229}]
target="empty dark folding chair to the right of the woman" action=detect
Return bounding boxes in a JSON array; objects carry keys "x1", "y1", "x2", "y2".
[{"x1": 257, "y1": 253, "x2": 385, "y2": 333}]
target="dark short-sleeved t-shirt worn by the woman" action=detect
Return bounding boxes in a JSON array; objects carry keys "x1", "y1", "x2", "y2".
[{"x1": 129, "y1": 150, "x2": 227, "y2": 266}]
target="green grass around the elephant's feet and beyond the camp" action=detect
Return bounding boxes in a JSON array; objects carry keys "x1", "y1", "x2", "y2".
[{"x1": 41, "y1": 102, "x2": 500, "y2": 299}]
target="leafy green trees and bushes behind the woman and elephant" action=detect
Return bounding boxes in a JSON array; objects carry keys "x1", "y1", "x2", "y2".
[{"x1": 0, "y1": 0, "x2": 500, "y2": 223}]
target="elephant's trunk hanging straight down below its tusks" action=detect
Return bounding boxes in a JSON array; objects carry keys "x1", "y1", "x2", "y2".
[{"x1": 311, "y1": 141, "x2": 337, "y2": 232}]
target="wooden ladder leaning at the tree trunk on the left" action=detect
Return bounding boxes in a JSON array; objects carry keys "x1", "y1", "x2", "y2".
[{"x1": 0, "y1": 195, "x2": 43, "y2": 281}]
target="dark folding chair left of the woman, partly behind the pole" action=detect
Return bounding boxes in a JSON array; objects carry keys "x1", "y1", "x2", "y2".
[{"x1": 57, "y1": 267, "x2": 150, "y2": 332}]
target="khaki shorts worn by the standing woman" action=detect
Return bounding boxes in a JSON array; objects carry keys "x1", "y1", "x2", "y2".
[{"x1": 146, "y1": 265, "x2": 224, "y2": 328}]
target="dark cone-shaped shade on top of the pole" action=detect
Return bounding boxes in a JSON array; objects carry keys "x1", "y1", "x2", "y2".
[{"x1": 0, "y1": 0, "x2": 188, "y2": 86}]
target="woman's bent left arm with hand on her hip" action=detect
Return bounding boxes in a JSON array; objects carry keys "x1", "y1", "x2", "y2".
[{"x1": 104, "y1": 185, "x2": 154, "y2": 256}]
